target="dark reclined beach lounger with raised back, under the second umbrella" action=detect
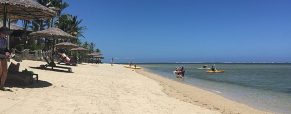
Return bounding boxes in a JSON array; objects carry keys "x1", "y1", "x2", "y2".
[{"x1": 40, "y1": 56, "x2": 72, "y2": 72}]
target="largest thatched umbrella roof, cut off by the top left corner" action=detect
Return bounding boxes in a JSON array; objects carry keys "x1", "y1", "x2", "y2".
[{"x1": 0, "y1": 0, "x2": 56, "y2": 20}]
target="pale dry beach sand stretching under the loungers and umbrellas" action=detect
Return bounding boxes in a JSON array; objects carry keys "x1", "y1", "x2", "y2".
[{"x1": 0, "y1": 60, "x2": 220, "y2": 114}]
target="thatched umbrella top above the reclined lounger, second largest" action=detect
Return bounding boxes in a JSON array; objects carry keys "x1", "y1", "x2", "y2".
[{"x1": 29, "y1": 28, "x2": 76, "y2": 39}]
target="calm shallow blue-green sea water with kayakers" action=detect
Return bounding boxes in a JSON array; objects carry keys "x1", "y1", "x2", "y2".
[{"x1": 141, "y1": 64, "x2": 291, "y2": 114}]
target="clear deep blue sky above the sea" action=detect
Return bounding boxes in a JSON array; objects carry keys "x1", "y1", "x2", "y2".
[{"x1": 64, "y1": 0, "x2": 291, "y2": 62}]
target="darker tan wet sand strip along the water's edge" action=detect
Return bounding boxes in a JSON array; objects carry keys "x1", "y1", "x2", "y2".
[{"x1": 136, "y1": 68, "x2": 272, "y2": 114}]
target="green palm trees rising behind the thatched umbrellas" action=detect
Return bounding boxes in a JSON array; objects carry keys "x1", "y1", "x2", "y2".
[{"x1": 18, "y1": 0, "x2": 101, "y2": 56}]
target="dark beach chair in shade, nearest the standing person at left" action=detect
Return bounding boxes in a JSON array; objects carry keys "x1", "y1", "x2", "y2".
[{"x1": 7, "y1": 62, "x2": 38, "y2": 85}]
